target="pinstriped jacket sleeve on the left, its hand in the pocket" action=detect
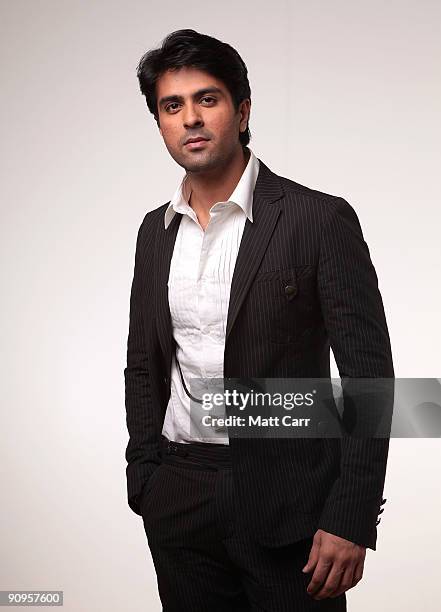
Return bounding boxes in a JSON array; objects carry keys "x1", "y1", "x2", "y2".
[{"x1": 124, "y1": 213, "x2": 160, "y2": 515}]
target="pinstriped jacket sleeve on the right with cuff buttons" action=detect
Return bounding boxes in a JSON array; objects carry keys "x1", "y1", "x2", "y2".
[{"x1": 318, "y1": 198, "x2": 394, "y2": 550}]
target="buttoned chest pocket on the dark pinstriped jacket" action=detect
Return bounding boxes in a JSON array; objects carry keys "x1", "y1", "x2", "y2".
[{"x1": 253, "y1": 265, "x2": 317, "y2": 344}]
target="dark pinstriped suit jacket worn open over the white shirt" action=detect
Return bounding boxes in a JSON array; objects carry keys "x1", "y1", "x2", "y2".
[{"x1": 124, "y1": 160, "x2": 394, "y2": 550}]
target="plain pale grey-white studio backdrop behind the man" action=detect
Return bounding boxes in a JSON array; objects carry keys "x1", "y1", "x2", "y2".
[{"x1": 0, "y1": 0, "x2": 441, "y2": 612}]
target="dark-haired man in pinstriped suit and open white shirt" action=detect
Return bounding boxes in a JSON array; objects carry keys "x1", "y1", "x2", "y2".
[{"x1": 125, "y1": 30, "x2": 394, "y2": 612}]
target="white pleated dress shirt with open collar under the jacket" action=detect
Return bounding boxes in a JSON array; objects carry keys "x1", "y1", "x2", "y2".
[{"x1": 162, "y1": 147, "x2": 259, "y2": 444}]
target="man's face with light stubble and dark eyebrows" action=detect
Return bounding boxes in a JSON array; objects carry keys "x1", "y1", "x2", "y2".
[{"x1": 156, "y1": 67, "x2": 251, "y2": 172}]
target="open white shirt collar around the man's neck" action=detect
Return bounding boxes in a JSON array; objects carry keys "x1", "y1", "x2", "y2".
[{"x1": 164, "y1": 147, "x2": 259, "y2": 229}]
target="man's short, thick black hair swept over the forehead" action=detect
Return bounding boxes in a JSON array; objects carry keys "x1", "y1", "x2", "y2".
[{"x1": 137, "y1": 29, "x2": 251, "y2": 147}]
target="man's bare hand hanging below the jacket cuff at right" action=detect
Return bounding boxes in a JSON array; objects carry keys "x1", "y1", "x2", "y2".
[{"x1": 302, "y1": 529, "x2": 366, "y2": 599}]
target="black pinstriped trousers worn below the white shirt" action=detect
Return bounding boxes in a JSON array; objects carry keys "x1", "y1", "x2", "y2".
[{"x1": 141, "y1": 438, "x2": 346, "y2": 612}]
